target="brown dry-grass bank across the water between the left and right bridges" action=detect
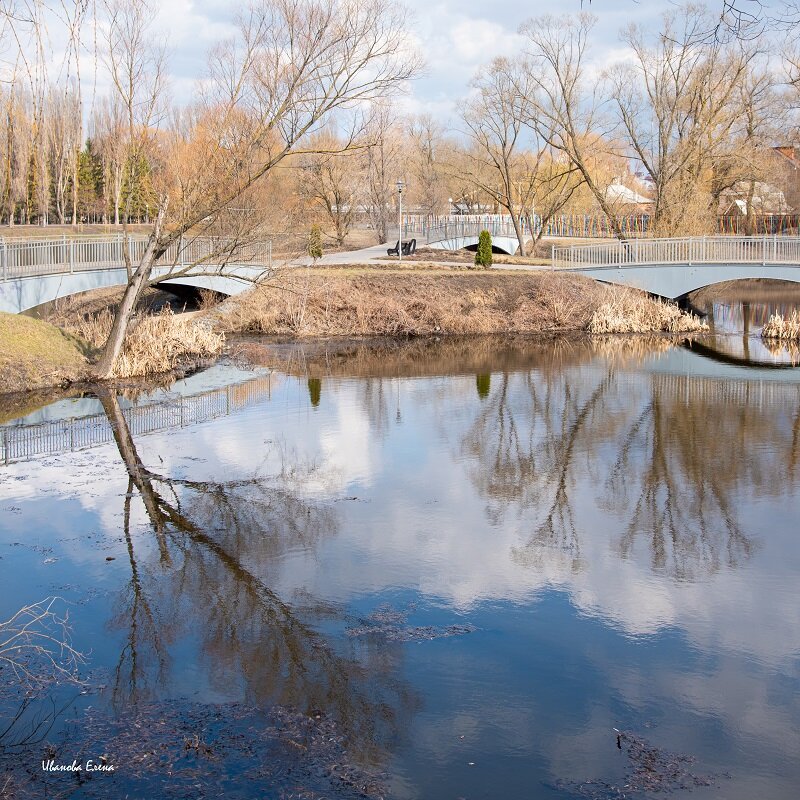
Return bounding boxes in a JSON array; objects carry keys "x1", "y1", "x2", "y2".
[{"x1": 214, "y1": 268, "x2": 704, "y2": 338}]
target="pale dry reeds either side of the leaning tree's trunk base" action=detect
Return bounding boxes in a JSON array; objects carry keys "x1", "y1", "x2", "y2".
[{"x1": 63, "y1": 307, "x2": 225, "y2": 378}]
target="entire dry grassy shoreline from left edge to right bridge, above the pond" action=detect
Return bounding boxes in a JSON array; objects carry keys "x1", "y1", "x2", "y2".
[{"x1": 0, "y1": 267, "x2": 705, "y2": 406}]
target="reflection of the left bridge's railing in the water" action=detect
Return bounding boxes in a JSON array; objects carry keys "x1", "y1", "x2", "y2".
[{"x1": 0, "y1": 375, "x2": 271, "y2": 464}]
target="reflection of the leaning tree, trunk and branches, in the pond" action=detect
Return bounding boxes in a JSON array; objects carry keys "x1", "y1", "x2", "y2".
[{"x1": 100, "y1": 392, "x2": 416, "y2": 760}]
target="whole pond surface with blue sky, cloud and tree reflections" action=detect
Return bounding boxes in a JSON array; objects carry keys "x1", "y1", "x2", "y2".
[{"x1": 0, "y1": 338, "x2": 800, "y2": 800}]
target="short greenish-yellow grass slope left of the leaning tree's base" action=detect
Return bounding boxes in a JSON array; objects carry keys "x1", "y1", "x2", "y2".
[{"x1": 0, "y1": 312, "x2": 92, "y2": 392}]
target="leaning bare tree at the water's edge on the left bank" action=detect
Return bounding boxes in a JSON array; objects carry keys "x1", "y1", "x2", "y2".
[{"x1": 96, "y1": 0, "x2": 417, "y2": 376}]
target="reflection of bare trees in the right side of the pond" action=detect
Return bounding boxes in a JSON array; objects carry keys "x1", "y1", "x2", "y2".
[{"x1": 450, "y1": 339, "x2": 800, "y2": 580}]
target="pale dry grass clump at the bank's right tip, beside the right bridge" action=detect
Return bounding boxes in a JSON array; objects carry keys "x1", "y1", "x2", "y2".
[{"x1": 587, "y1": 288, "x2": 708, "y2": 333}]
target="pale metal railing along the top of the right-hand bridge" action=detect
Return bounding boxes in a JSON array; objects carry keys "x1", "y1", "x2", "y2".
[{"x1": 552, "y1": 236, "x2": 800, "y2": 269}]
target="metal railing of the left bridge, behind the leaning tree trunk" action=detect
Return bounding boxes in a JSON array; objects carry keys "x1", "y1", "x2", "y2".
[{"x1": 0, "y1": 235, "x2": 272, "y2": 281}]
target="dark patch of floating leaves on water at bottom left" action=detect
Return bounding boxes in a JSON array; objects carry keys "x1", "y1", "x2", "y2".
[{"x1": 0, "y1": 701, "x2": 386, "y2": 800}]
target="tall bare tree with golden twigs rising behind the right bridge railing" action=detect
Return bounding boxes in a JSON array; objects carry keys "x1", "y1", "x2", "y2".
[{"x1": 611, "y1": 6, "x2": 758, "y2": 236}]
